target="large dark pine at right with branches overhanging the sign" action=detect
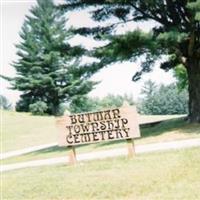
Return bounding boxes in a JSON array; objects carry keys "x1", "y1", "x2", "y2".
[{"x1": 62, "y1": 0, "x2": 200, "y2": 122}]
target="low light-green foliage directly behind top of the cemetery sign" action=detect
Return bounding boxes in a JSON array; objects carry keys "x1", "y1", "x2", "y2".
[{"x1": 69, "y1": 94, "x2": 134, "y2": 113}]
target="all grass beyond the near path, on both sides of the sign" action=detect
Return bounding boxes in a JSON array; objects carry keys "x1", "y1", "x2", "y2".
[{"x1": 1, "y1": 109, "x2": 200, "y2": 164}]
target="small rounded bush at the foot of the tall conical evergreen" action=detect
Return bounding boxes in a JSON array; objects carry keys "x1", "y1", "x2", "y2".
[{"x1": 29, "y1": 101, "x2": 48, "y2": 115}]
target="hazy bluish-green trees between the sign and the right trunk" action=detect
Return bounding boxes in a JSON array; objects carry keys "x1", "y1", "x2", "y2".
[{"x1": 138, "y1": 81, "x2": 188, "y2": 115}]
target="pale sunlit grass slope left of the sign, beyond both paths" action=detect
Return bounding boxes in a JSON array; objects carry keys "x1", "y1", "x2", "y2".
[{"x1": 1, "y1": 110, "x2": 57, "y2": 152}]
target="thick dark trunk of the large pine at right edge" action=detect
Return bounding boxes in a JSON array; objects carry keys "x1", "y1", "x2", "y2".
[{"x1": 187, "y1": 58, "x2": 200, "y2": 123}]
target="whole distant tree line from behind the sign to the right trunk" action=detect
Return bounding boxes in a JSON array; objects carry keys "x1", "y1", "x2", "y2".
[{"x1": 68, "y1": 81, "x2": 188, "y2": 115}]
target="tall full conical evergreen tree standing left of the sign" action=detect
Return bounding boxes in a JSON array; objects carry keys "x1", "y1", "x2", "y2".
[{"x1": 1, "y1": 0, "x2": 95, "y2": 115}]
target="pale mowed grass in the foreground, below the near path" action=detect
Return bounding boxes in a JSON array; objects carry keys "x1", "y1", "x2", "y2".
[{"x1": 2, "y1": 148, "x2": 200, "y2": 200}]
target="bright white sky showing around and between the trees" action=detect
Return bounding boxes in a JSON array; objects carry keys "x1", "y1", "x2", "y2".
[{"x1": 0, "y1": 0, "x2": 174, "y2": 104}]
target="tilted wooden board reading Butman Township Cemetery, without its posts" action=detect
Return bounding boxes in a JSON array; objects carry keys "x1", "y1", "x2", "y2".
[{"x1": 57, "y1": 106, "x2": 140, "y2": 146}]
